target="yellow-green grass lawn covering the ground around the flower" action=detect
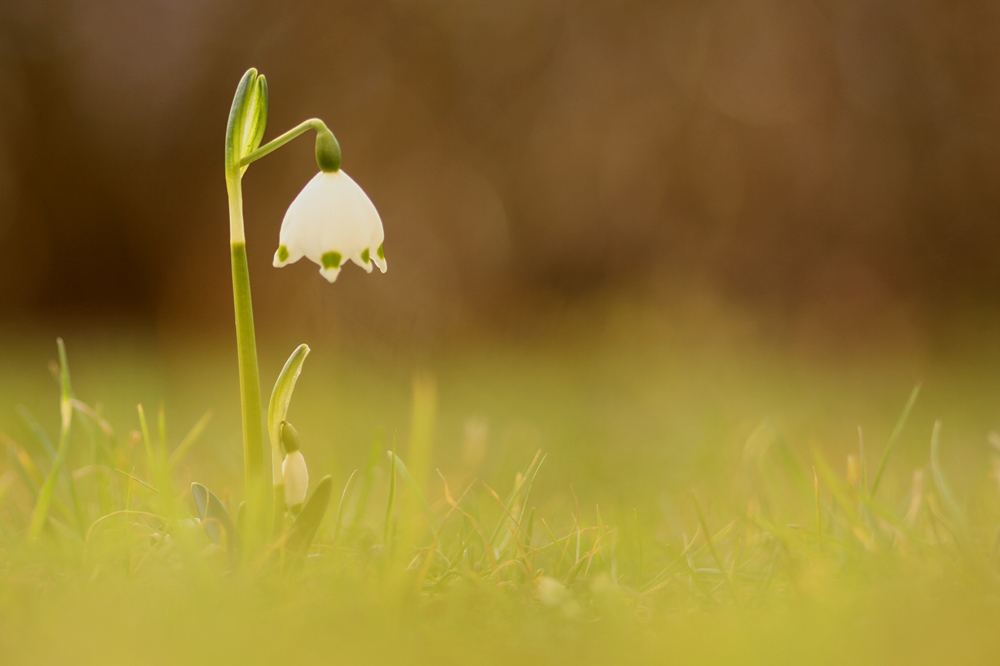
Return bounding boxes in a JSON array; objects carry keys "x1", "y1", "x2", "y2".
[{"x1": 0, "y1": 302, "x2": 1000, "y2": 664}]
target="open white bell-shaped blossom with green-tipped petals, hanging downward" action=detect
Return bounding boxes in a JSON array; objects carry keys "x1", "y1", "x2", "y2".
[{"x1": 274, "y1": 169, "x2": 386, "y2": 282}]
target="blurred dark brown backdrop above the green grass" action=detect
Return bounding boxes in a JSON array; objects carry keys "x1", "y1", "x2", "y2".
[{"x1": 0, "y1": 0, "x2": 1000, "y2": 350}]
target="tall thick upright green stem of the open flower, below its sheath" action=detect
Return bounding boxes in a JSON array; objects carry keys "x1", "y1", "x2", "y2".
[{"x1": 226, "y1": 171, "x2": 270, "y2": 552}]
